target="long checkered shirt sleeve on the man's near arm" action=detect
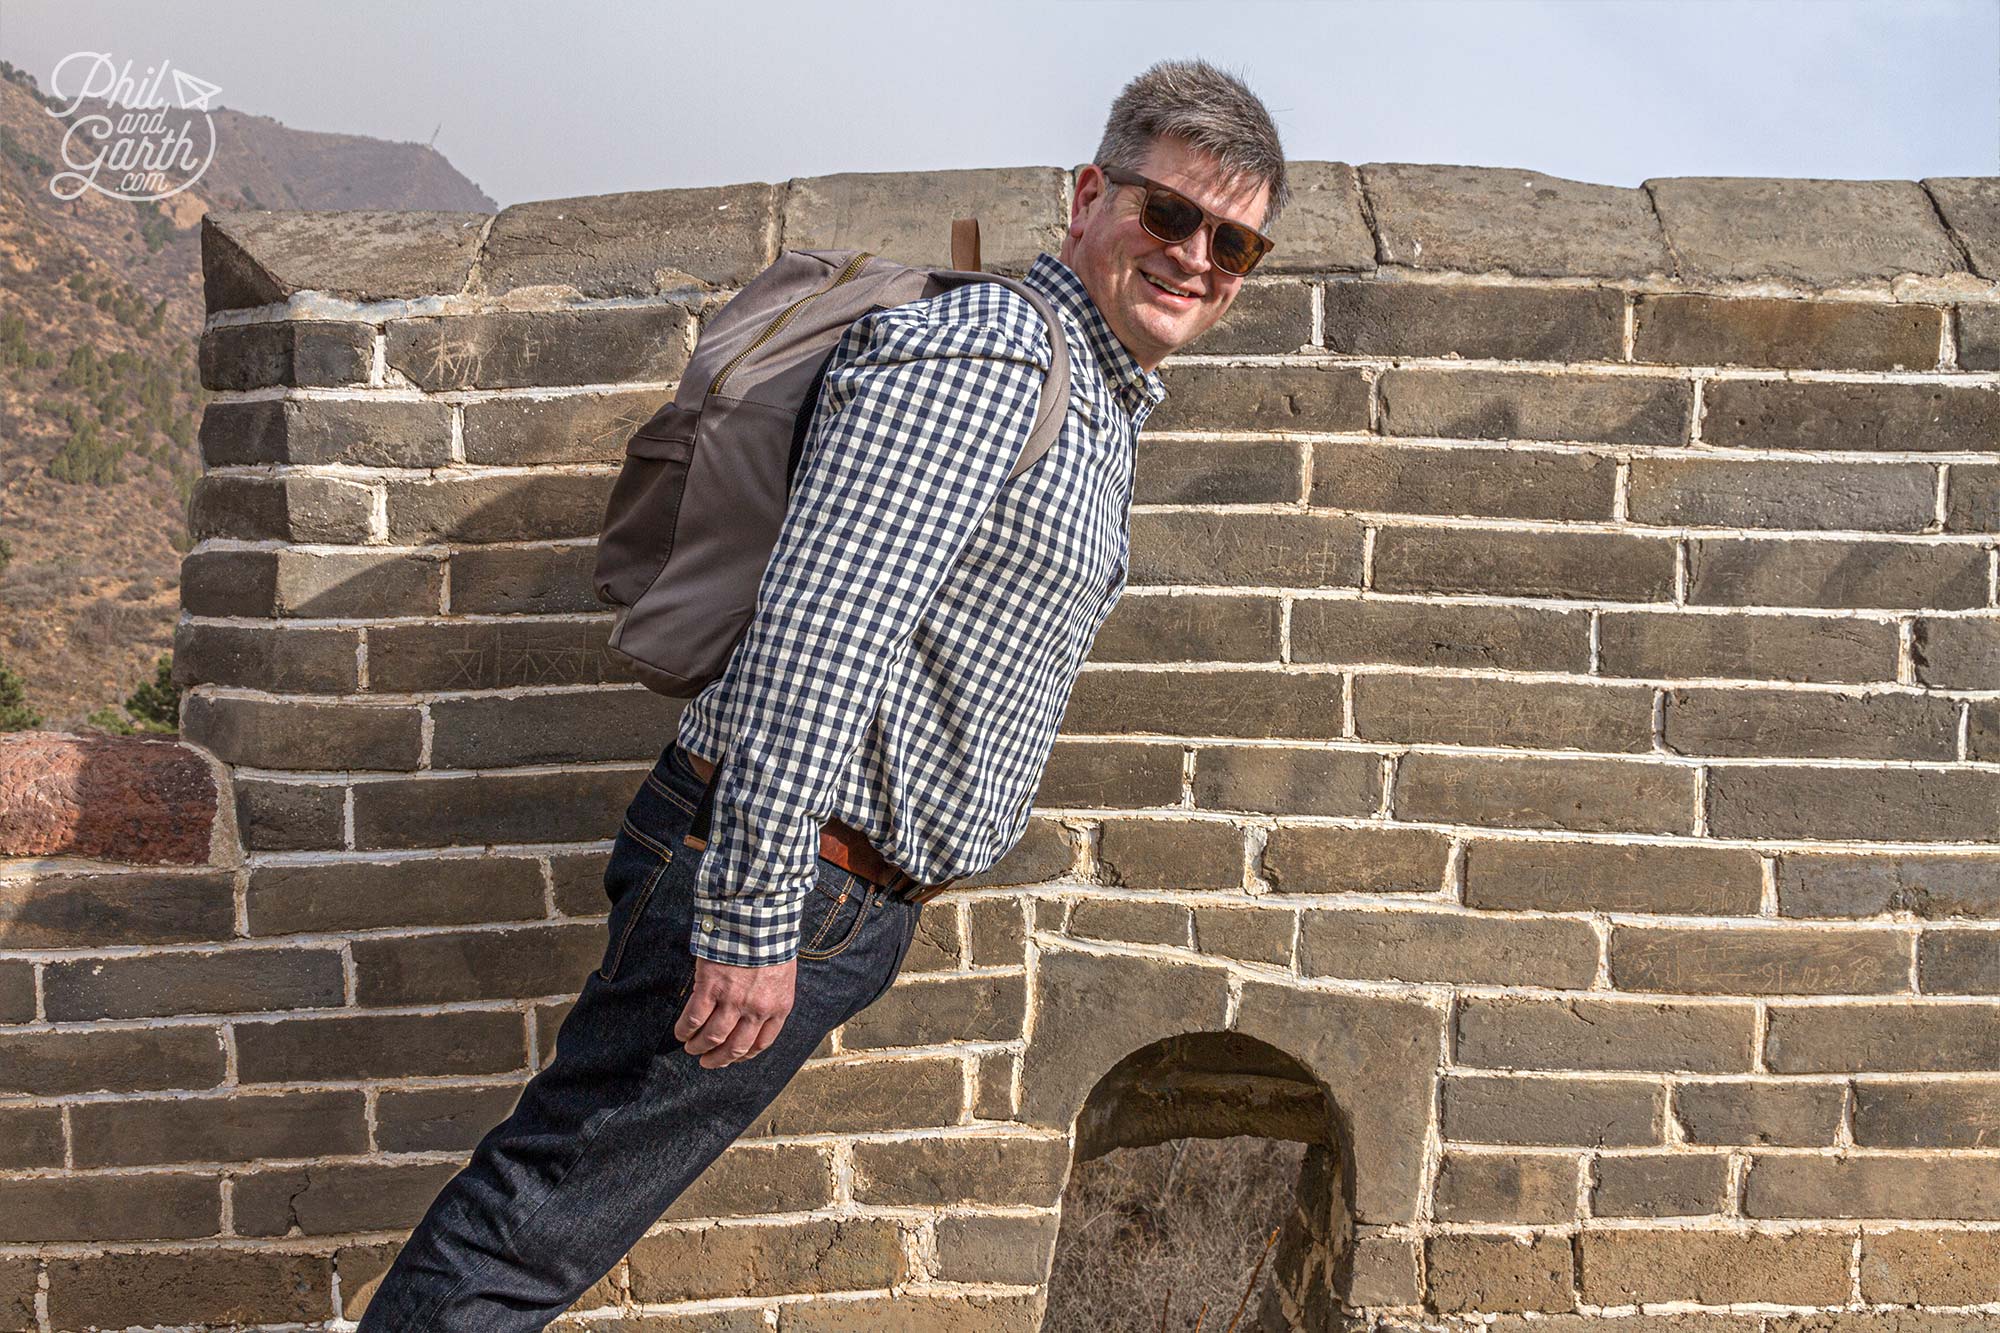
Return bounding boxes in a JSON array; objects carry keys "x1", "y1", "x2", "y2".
[{"x1": 690, "y1": 298, "x2": 1050, "y2": 967}]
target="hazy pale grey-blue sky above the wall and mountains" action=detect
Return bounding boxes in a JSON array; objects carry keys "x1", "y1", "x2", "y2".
[{"x1": 0, "y1": 0, "x2": 2000, "y2": 204}]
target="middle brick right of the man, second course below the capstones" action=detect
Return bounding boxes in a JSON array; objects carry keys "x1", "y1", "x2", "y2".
[{"x1": 1380, "y1": 370, "x2": 1692, "y2": 444}]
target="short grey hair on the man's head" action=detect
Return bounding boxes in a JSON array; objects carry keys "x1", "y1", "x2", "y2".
[{"x1": 1094, "y1": 58, "x2": 1292, "y2": 232}]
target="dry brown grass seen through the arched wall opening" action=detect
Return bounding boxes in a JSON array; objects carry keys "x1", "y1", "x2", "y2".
[{"x1": 1042, "y1": 1137, "x2": 1306, "y2": 1333}]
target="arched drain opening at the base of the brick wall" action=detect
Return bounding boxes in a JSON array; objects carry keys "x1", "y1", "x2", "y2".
[{"x1": 1042, "y1": 1033, "x2": 1352, "y2": 1333}]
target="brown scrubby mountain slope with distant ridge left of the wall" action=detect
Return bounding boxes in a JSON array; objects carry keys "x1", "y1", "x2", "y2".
[{"x1": 0, "y1": 60, "x2": 496, "y2": 727}]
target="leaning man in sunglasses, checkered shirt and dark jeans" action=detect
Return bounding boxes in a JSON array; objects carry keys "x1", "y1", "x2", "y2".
[{"x1": 362, "y1": 60, "x2": 1288, "y2": 1333}]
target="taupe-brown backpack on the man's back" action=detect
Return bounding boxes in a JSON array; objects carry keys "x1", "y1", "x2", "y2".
[{"x1": 596, "y1": 220, "x2": 1070, "y2": 699}]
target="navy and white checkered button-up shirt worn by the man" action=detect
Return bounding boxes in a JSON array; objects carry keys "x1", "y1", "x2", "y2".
[{"x1": 680, "y1": 254, "x2": 1166, "y2": 965}]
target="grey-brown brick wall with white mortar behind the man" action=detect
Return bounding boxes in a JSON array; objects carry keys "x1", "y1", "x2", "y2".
[{"x1": 0, "y1": 162, "x2": 2000, "y2": 1333}]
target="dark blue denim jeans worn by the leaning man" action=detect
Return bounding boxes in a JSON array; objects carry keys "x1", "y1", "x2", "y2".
[{"x1": 360, "y1": 745, "x2": 922, "y2": 1333}]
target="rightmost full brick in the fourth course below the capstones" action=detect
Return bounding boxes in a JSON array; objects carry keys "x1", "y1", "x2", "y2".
[{"x1": 1688, "y1": 536, "x2": 1986, "y2": 610}]
